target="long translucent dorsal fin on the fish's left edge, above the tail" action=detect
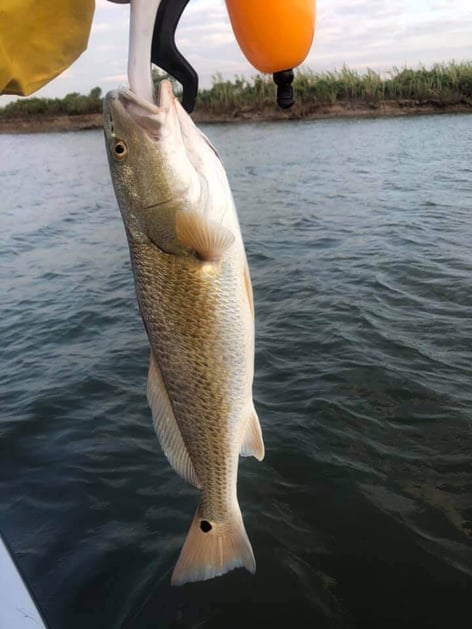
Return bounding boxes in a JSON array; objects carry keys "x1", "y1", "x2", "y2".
[{"x1": 147, "y1": 352, "x2": 201, "y2": 488}]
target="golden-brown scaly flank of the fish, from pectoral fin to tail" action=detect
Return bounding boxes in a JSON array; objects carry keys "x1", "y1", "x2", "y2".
[{"x1": 132, "y1": 245, "x2": 245, "y2": 521}]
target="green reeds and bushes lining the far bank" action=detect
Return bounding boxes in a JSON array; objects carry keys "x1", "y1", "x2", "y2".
[{"x1": 0, "y1": 61, "x2": 472, "y2": 120}]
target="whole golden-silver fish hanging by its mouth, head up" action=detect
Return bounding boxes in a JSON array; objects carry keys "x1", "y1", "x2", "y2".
[{"x1": 104, "y1": 82, "x2": 264, "y2": 584}]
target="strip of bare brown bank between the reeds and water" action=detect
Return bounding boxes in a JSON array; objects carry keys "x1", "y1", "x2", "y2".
[{"x1": 0, "y1": 101, "x2": 472, "y2": 134}]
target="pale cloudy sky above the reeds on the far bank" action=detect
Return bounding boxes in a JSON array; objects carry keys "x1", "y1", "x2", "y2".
[{"x1": 0, "y1": 0, "x2": 472, "y2": 106}]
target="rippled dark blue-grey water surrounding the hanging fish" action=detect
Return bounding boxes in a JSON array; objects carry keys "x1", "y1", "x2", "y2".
[{"x1": 0, "y1": 115, "x2": 472, "y2": 629}]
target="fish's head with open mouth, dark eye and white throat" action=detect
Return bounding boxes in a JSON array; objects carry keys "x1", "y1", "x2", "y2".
[{"x1": 103, "y1": 81, "x2": 239, "y2": 252}]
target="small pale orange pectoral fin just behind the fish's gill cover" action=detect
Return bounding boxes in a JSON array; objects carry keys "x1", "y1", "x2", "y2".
[{"x1": 175, "y1": 211, "x2": 234, "y2": 262}]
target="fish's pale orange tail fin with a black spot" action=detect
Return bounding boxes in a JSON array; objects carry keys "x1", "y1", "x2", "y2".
[{"x1": 171, "y1": 505, "x2": 256, "y2": 585}]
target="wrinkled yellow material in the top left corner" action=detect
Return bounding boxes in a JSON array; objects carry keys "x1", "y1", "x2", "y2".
[{"x1": 0, "y1": 0, "x2": 95, "y2": 96}]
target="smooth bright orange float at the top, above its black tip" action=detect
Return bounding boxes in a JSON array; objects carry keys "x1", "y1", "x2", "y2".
[{"x1": 226, "y1": 0, "x2": 316, "y2": 73}]
